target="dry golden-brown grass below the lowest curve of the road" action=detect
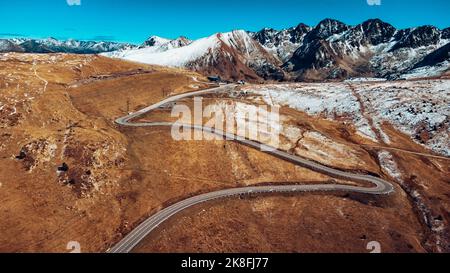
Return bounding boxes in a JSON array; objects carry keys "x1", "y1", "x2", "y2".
[{"x1": 134, "y1": 194, "x2": 425, "y2": 253}]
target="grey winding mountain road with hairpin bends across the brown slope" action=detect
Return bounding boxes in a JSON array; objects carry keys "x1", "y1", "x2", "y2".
[{"x1": 107, "y1": 84, "x2": 394, "y2": 253}]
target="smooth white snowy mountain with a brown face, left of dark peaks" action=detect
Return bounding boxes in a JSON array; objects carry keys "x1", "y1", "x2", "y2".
[{"x1": 104, "y1": 30, "x2": 284, "y2": 80}]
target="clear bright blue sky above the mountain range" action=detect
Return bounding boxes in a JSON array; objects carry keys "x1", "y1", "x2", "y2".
[{"x1": 0, "y1": 0, "x2": 450, "y2": 43}]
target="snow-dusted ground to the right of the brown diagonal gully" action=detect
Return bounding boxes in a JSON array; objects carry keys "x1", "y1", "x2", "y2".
[{"x1": 354, "y1": 80, "x2": 450, "y2": 156}]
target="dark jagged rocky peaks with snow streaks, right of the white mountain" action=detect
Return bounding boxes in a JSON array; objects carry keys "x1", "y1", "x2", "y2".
[{"x1": 283, "y1": 19, "x2": 450, "y2": 80}]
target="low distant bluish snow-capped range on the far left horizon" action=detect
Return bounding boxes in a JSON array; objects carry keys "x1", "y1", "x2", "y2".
[{"x1": 0, "y1": 38, "x2": 134, "y2": 54}]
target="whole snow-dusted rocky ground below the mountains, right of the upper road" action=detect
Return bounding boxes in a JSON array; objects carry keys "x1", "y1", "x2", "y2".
[{"x1": 246, "y1": 80, "x2": 450, "y2": 156}]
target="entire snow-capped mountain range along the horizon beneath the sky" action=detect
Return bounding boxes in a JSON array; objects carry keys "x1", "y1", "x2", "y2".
[{"x1": 0, "y1": 19, "x2": 450, "y2": 81}]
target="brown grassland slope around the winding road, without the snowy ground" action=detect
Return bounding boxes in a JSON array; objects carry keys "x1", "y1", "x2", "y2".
[{"x1": 0, "y1": 54, "x2": 449, "y2": 252}]
